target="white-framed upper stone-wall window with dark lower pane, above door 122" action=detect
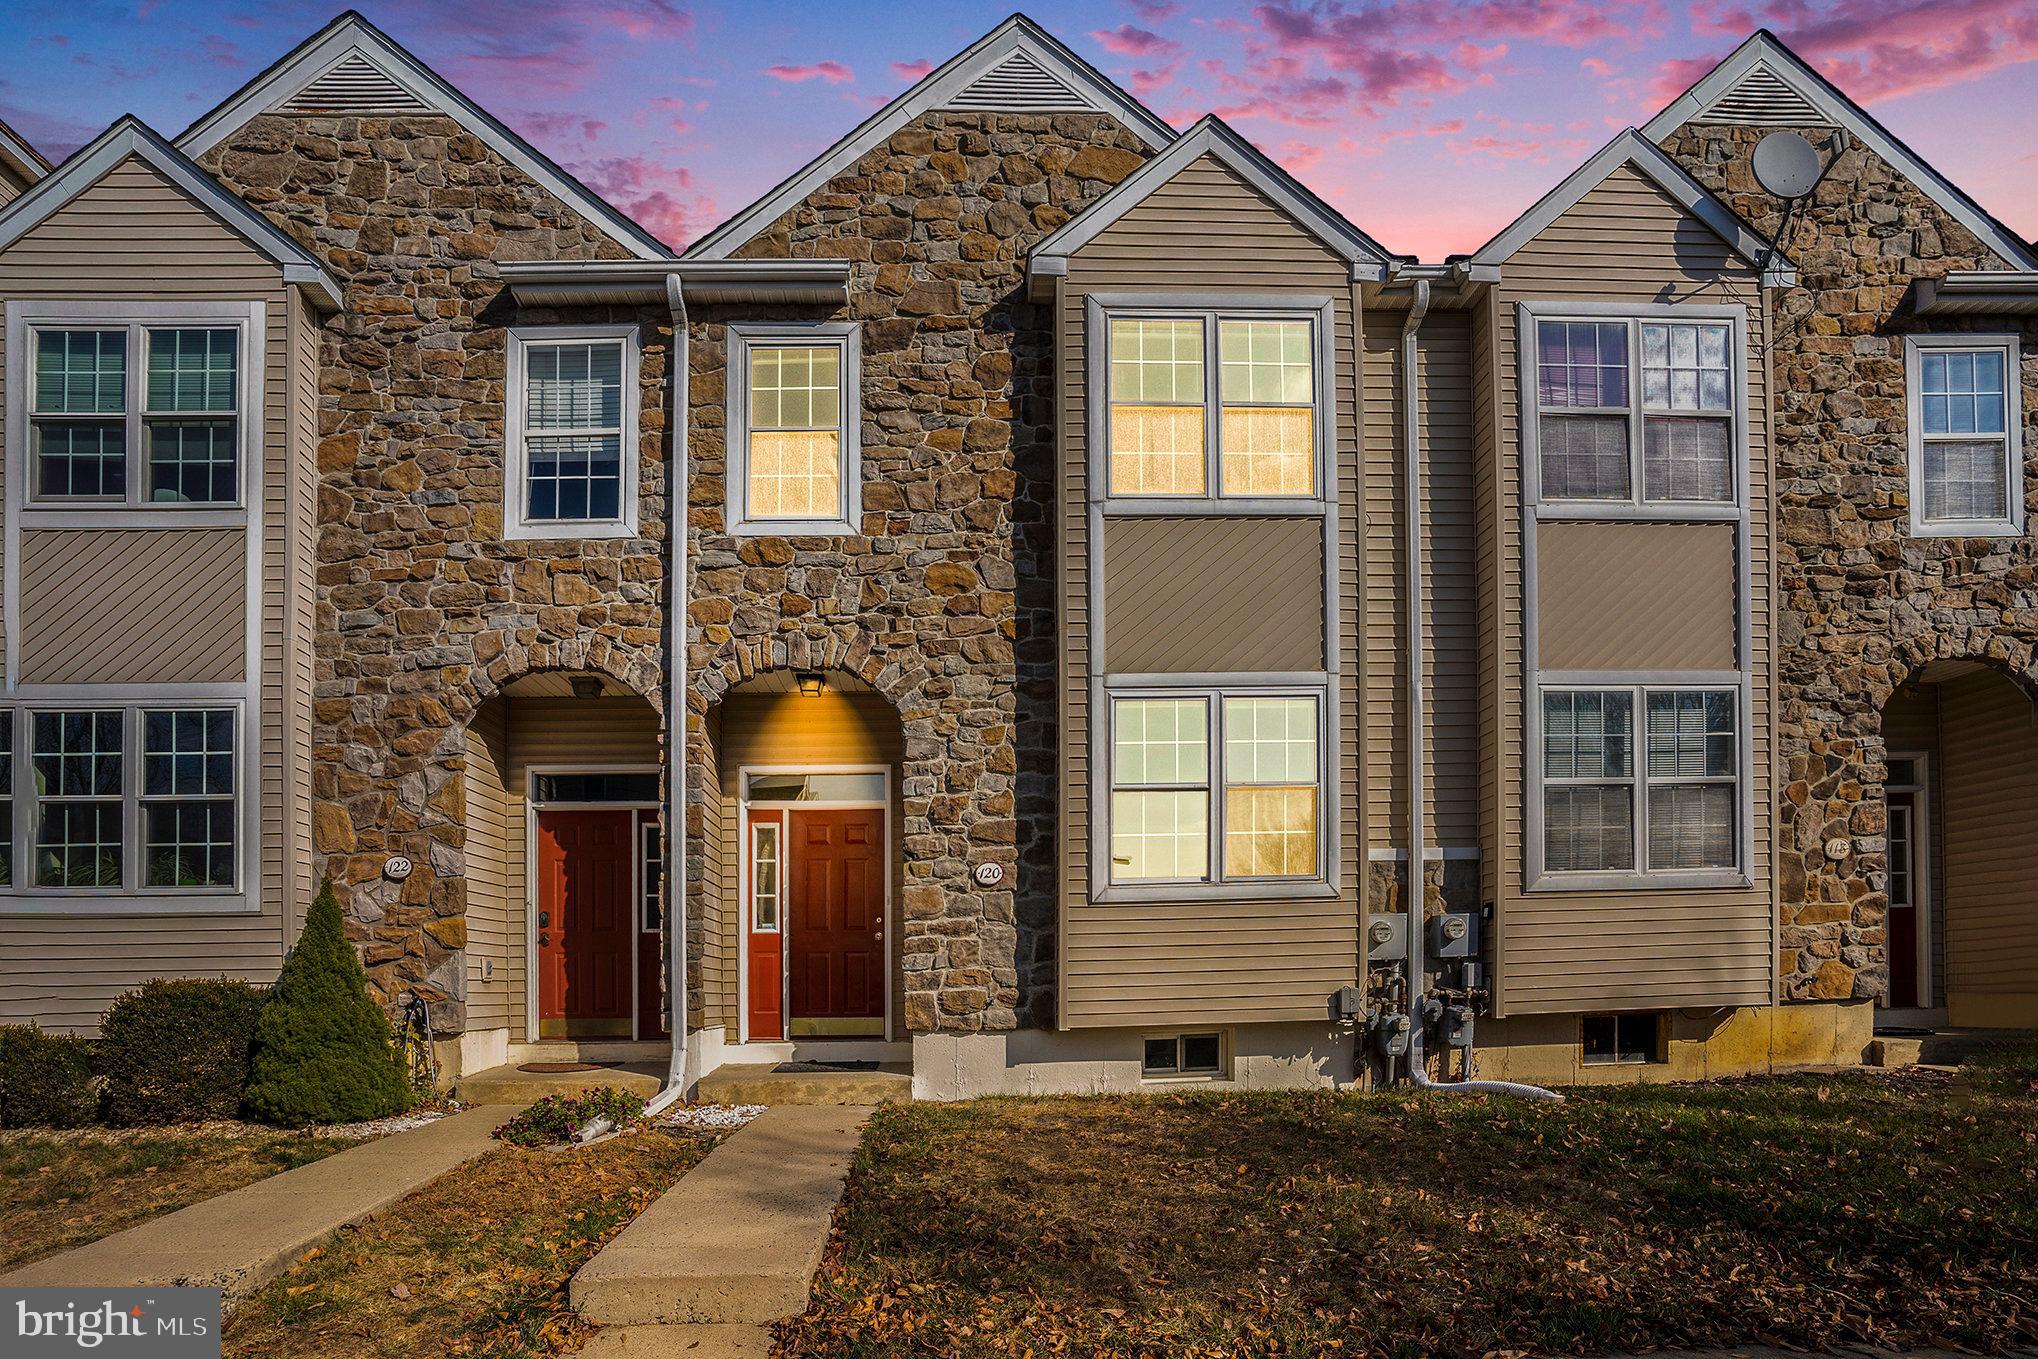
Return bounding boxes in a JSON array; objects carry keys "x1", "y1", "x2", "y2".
[{"x1": 503, "y1": 326, "x2": 638, "y2": 538}]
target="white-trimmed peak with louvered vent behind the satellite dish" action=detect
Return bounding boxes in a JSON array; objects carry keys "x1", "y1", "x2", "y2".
[{"x1": 1643, "y1": 29, "x2": 2038, "y2": 269}]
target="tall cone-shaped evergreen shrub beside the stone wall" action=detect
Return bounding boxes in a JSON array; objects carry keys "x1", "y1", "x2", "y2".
[{"x1": 245, "y1": 878, "x2": 410, "y2": 1129}]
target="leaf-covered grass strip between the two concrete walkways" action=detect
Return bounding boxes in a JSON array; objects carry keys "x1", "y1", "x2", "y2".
[{"x1": 224, "y1": 1131, "x2": 717, "y2": 1359}]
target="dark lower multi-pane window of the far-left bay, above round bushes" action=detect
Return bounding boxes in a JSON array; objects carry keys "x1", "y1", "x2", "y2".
[{"x1": 12, "y1": 705, "x2": 243, "y2": 894}]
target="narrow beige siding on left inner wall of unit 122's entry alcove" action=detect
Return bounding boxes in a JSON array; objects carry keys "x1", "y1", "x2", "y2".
[{"x1": 461, "y1": 699, "x2": 517, "y2": 1039}]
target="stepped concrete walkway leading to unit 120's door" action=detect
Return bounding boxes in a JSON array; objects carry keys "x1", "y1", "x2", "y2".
[{"x1": 571, "y1": 1104, "x2": 870, "y2": 1359}]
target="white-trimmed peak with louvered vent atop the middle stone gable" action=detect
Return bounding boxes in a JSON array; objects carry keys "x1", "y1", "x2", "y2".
[{"x1": 687, "y1": 14, "x2": 1174, "y2": 259}]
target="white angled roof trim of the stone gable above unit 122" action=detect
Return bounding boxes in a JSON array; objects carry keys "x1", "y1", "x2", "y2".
[{"x1": 177, "y1": 12, "x2": 673, "y2": 259}]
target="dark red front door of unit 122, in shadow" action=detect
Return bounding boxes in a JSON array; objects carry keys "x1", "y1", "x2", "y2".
[{"x1": 538, "y1": 811, "x2": 638, "y2": 1037}]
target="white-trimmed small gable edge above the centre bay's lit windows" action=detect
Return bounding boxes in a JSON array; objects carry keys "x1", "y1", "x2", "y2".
[{"x1": 1027, "y1": 114, "x2": 1396, "y2": 281}]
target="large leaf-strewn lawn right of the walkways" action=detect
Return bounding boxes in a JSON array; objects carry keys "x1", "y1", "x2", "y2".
[{"x1": 779, "y1": 1051, "x2": 2038, "y2": 1359}]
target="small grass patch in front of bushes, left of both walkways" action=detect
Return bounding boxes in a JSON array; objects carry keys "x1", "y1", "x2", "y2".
[{"x1": 0, "y1": 1123, "x2": 361, "y2": 1271}]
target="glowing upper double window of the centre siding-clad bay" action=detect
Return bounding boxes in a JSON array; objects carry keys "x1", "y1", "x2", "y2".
[{"x1": 1105, "y1": 312, "x2": 1323, "y2": 499}]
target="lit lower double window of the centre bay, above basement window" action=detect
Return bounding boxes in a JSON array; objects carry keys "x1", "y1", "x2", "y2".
[{"x1": 1109, "y1": 689, "x2": 1327, "y2": 886}]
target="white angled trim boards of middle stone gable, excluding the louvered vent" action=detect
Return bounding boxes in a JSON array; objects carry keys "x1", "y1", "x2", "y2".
[{"x1": 687, "y1": 14, "x2": 1174, "y2": 259}]
